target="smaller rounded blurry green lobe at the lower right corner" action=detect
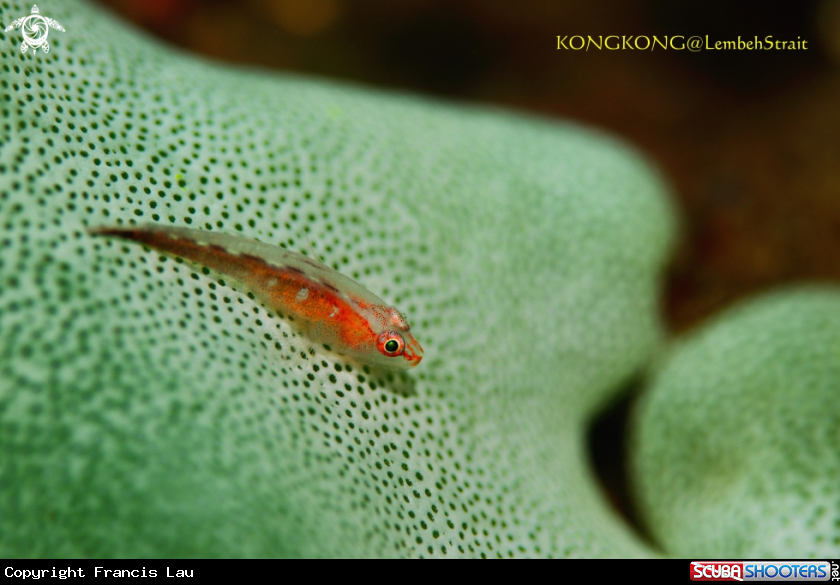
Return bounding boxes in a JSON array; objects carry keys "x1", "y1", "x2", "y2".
[{"x1": 631, "y1": 288, "x2": 840, "y2": 558}]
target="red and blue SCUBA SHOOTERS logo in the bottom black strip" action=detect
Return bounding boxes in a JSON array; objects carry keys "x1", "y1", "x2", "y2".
[{"x1": 690, "y1": 561, "x2": 840, "y2": 581}]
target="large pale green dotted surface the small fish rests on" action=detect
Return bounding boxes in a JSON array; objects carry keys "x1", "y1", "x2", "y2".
[{"x1": 0, "y1": 0, "x2": 673, "y2": 557}]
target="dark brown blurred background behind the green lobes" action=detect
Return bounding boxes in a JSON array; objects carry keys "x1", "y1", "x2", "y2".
[{"x1": 92, "y1": 0, "x2": 840, "y2": 540}]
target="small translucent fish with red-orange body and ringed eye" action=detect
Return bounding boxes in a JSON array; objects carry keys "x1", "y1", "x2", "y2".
[{"x1": 90, "y1": 225, "x2": 423, "y2": 370}]
